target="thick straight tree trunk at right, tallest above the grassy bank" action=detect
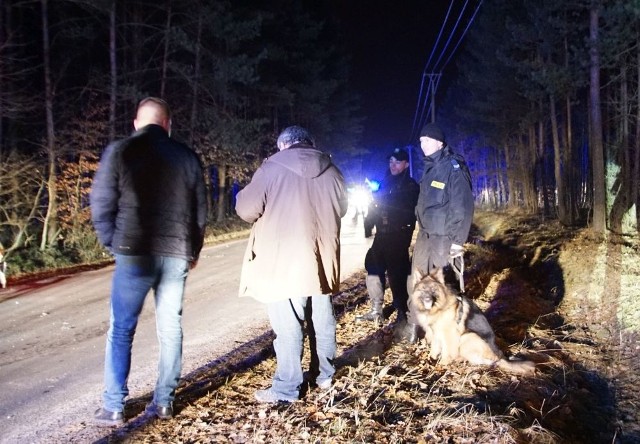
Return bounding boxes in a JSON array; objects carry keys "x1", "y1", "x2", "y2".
[{"x1": 589, "y1": 4, "x2": 607, "y2": 234}]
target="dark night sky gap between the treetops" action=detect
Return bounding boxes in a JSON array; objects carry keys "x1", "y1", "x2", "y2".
[{"x1": 333, "y1": 0, "x2": 464, "y2": 149}]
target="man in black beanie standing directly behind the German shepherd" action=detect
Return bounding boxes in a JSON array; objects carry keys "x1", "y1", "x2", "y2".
[{"x1": 406, "y1": 123, "x2": 474, "y2": 343}]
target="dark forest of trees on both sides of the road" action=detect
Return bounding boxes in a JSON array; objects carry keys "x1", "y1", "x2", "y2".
[{"x1": 0, "y1": 0, "x2": 640, "y2": 274}]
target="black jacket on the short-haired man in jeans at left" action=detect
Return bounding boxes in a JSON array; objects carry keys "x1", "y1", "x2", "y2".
[{"x1": 91, "y1": 125, "x2": 207, "y2": 260}]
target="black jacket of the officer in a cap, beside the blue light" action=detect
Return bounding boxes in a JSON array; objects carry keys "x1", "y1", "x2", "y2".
[{"x1": 364, "y1": 169, "x2": 420, "y2": 237}]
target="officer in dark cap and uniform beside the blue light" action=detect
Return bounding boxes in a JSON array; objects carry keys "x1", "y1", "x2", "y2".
[{"x1": 357, "y1": 148, "x2": 420, "y2": 322}]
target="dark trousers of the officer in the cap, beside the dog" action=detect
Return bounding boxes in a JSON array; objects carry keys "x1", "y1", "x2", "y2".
[{"x1": 364, "y1": 230, "x2": 413, "y2": 317}]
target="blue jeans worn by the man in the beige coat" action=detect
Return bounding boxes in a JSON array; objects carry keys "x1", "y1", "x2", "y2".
[{"x1": 267, "y1": 295, "x2": 336, "y2": 401}]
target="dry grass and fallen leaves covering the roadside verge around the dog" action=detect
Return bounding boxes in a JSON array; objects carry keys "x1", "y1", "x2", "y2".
[{"x1": 77, "y1": 215, "x2": 640, "y2": 443}]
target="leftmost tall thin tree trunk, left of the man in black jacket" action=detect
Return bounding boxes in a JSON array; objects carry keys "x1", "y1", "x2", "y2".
[{"x1": 40, "y1": 0, "x2": 58, "y2": 250}]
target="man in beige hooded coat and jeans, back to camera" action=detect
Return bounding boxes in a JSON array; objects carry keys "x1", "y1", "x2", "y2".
[{"x1": 236, "y1": 126, "x2": 347, "y2": 403}]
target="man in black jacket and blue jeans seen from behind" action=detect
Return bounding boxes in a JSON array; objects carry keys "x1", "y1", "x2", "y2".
[{"x1": 91, "y1": 97, "x2": 207, "y2": 426}]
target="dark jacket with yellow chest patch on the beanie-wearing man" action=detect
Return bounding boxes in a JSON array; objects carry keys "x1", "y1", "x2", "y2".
[{"x1": 416, "y1": 146, "x2": 474, "y2": 245}]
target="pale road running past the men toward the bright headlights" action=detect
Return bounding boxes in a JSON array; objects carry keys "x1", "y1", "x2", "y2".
[{"x1": 0, "y1": 210, "x2": 370, "y2": 443}]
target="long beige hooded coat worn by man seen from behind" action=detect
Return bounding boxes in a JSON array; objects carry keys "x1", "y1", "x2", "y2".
[{"x1": 236, "y1": 144, "x2": 347, "y2": 303}]
